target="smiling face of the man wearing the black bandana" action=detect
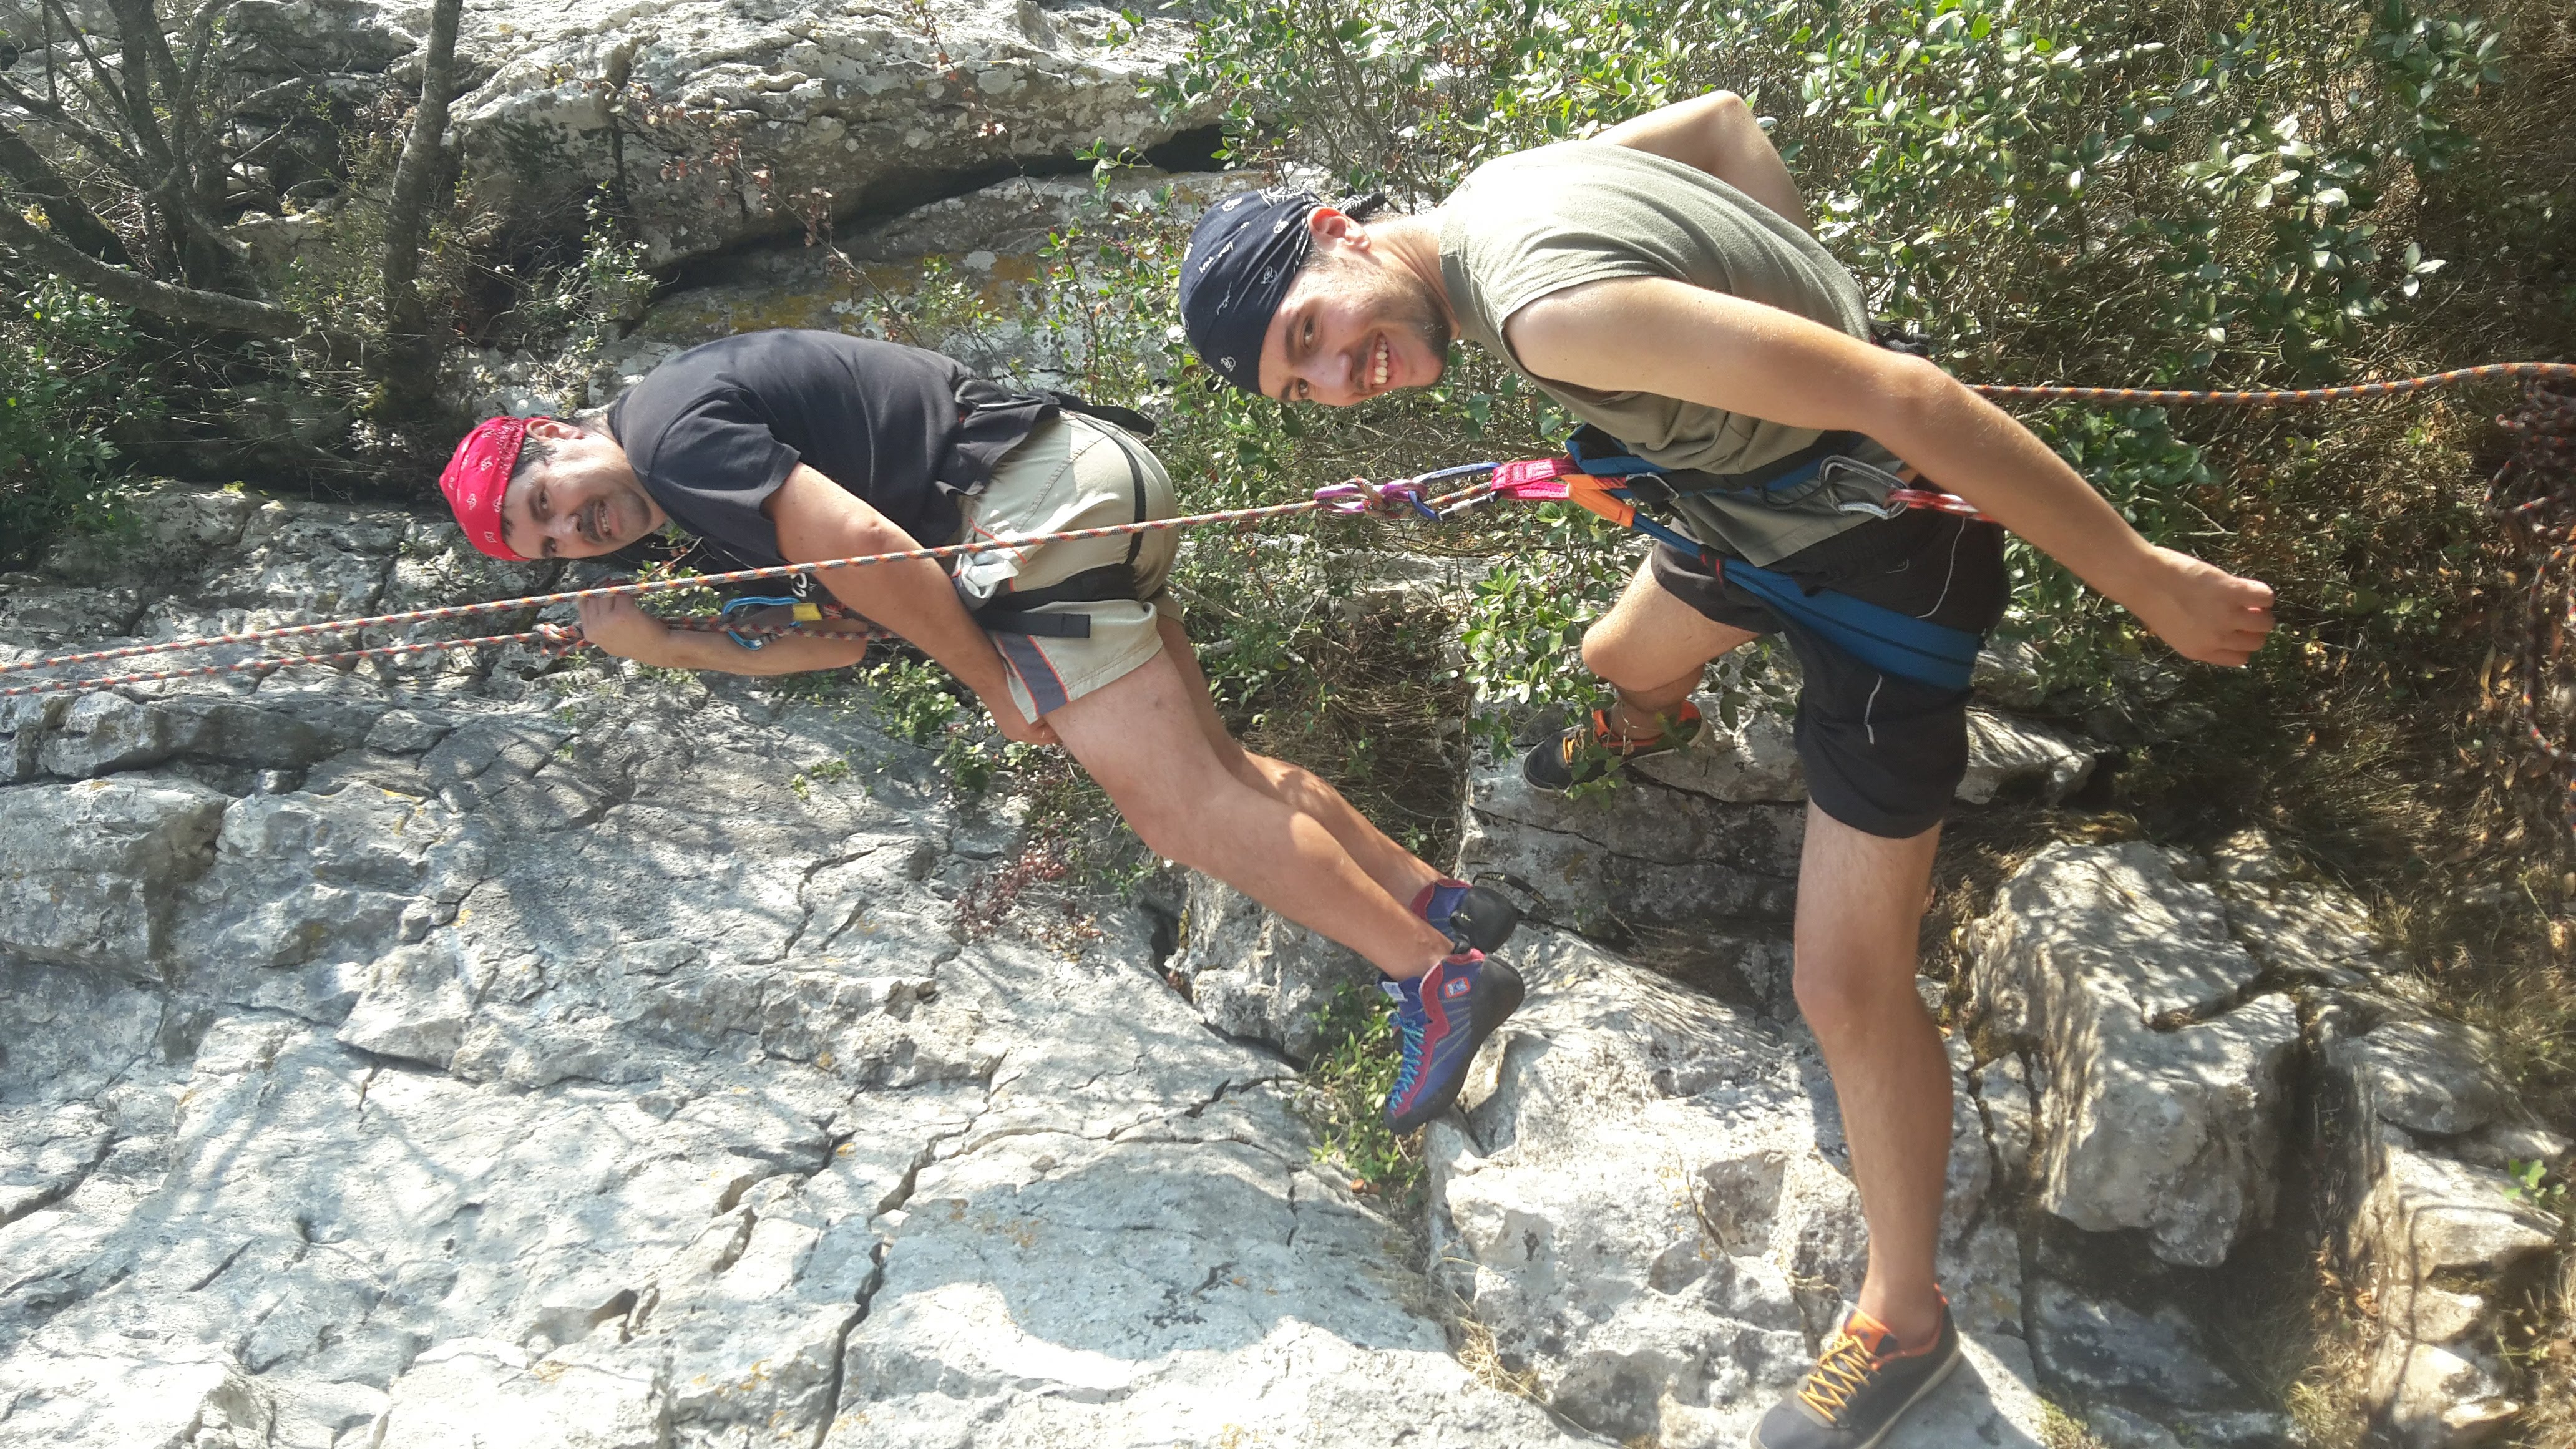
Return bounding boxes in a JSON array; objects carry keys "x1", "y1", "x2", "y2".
[{"x1": 1262, "y1": 232, "x2": 1450, "y2": 407}]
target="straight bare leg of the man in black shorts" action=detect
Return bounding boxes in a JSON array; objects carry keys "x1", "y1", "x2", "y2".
[{"x1": 1795, "y1": 804, "x2": 1950, "y2": 1349}]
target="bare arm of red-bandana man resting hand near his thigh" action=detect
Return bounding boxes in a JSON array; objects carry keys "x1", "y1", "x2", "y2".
[{"x1": 760, "y1": 464, "x2": 1056, "y2": 745}]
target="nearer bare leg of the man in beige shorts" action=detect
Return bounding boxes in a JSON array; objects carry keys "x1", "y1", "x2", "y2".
[{"x1": 1046, "y1": 650, "x2": 1453, "y2": 977}]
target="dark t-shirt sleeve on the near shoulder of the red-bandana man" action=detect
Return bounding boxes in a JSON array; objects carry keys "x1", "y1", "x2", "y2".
[{"x1": 621, "y1": 387, "x2": 801, "y2": 565}]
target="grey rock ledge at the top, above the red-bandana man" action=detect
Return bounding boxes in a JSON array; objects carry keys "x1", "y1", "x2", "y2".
[{"x1": 454, "y1": 0, "x2": 1216, "y2": 266}]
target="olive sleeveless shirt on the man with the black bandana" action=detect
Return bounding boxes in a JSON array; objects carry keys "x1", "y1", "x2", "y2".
[{"x1": 1440, "y1": 142, "x2": 1891, "y2": 565}]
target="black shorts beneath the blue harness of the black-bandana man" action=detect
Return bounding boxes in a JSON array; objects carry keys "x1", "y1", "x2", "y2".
[{"x1": 1654, "y1": 508, "x2": 2012, "y2": 841}]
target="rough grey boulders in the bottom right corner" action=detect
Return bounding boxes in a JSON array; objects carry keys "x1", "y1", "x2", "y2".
[{"x1": 1971, "y1": 833, "x2": 2569, "y2": 1449}]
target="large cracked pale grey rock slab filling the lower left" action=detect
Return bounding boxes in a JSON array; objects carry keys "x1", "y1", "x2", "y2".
[{"x1": 0, "y1": 492, "x2": 1571, "y2": 1449}]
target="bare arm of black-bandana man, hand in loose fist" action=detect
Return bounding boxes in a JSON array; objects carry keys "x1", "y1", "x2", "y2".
[{"x1": 1505, "y1": 278, "x2": 2272, "y2": 665}]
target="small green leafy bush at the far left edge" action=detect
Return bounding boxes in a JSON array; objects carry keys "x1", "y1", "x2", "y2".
[{"x1": 0, "y1": 276, "x2": 157, "y2": 567}]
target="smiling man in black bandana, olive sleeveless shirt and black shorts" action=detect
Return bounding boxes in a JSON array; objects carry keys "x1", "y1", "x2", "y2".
[{"x1": 1180, "y1": 93, "x2": 2272, "y2": 1449}]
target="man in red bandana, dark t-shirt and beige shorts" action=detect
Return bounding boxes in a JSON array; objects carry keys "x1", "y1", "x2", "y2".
[{"x1": 441, "y1": 333, "x2": 1517, "y2": 1129}]
